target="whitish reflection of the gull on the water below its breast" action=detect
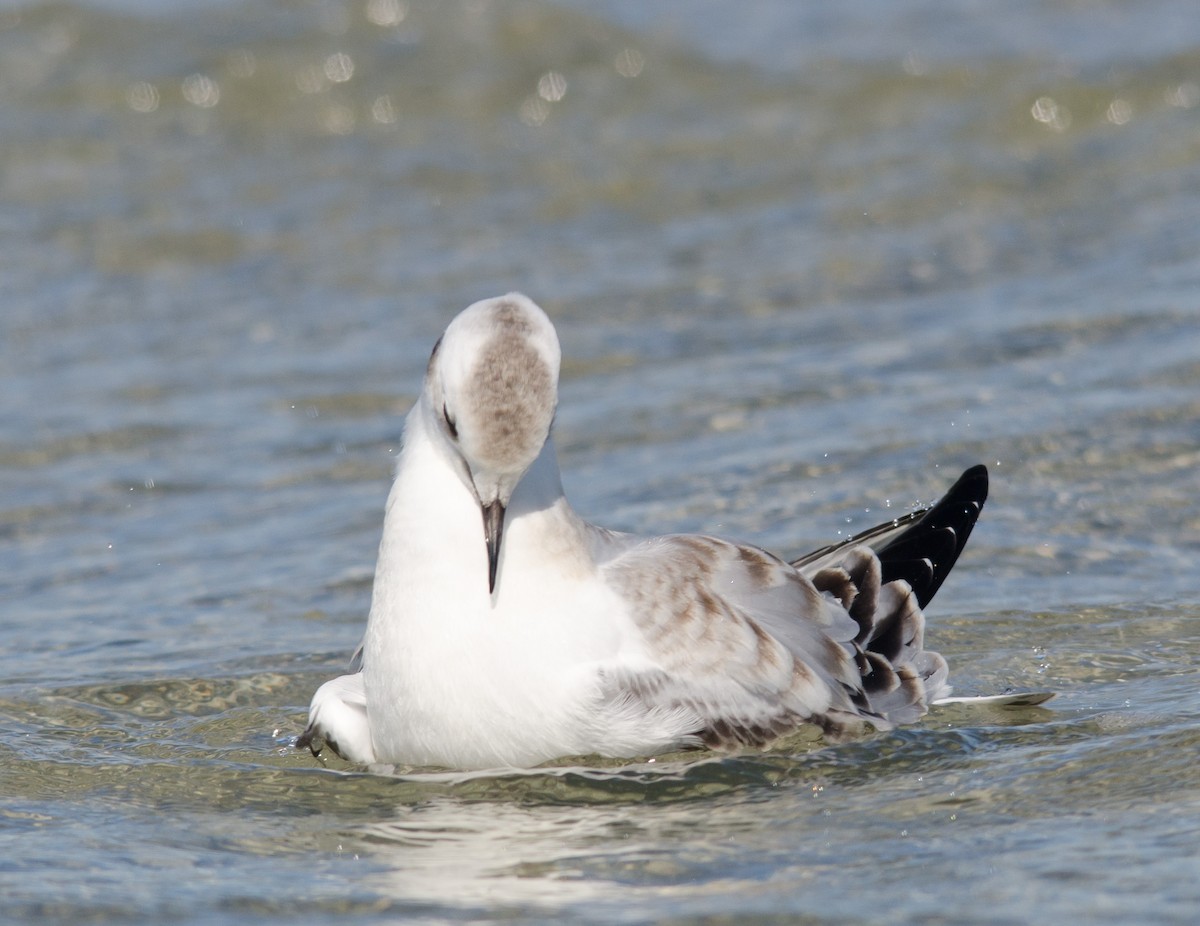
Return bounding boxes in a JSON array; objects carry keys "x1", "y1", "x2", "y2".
[{"x1": 343, "y1": 772, "x2": 792, "y2": 907}]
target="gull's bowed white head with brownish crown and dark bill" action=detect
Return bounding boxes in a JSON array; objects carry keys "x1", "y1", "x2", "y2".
[{"x1": 422, "y1": 293, "x2": 562, "y2": 593}]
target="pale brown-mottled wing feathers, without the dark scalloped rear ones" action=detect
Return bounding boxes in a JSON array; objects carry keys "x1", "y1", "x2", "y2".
[{"x1": 606, "y1": 536, "x2": 873, "y2": 746}]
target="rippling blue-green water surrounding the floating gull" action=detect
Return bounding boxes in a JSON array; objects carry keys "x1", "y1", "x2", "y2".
[{"x1": 0, "y1": 0, "x2": 1200, "y2": 924}]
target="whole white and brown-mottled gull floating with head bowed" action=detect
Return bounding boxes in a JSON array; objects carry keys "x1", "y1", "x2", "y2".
[{"x1": 296, "y1": 293, "x2": 1049, "y2": 770}]
